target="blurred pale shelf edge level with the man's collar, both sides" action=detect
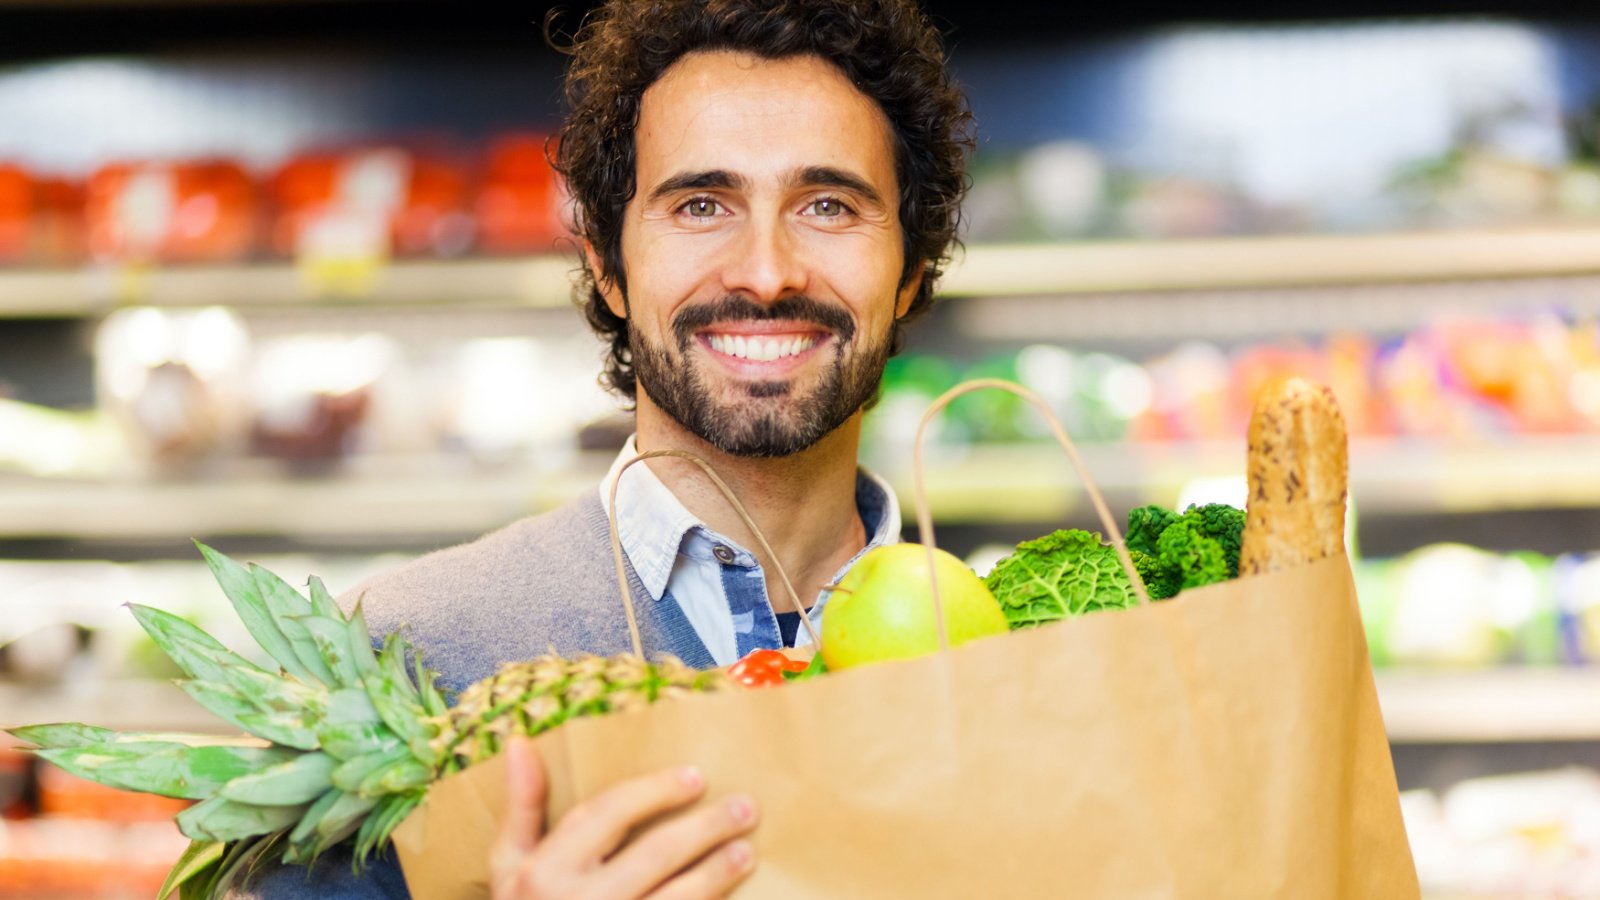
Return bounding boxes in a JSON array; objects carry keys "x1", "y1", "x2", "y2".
[{"x1": 0, "y1": 436, "x2": 1600, "y2": 540}]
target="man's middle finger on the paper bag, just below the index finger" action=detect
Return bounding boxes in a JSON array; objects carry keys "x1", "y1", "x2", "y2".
[{"x1": 597, "y1": 796, "x2": 757, "y2": 897}]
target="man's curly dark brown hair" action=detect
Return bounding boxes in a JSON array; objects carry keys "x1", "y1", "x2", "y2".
[{"x1": 552, "y1": 0, "x2": 973, "y2": 400}]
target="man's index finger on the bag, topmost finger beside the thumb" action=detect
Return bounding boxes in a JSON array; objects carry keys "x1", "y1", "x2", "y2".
[{"x1": 541, "y1": 769, "x2": 706, "y2": 866}]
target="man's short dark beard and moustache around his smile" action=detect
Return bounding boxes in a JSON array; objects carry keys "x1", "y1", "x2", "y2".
[{"x1": 627, "y1": 296, "x2": 890, "y2": 458}]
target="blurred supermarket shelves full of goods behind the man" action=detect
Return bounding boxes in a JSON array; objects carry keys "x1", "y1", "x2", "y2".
[{"x1": 0, "y1": 0, "x2": 1600, "y2": 898}]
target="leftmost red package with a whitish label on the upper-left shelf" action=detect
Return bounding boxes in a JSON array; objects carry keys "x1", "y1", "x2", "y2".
[{"x1": 85, "y1": 160, "x2": 258, "y2": 263}]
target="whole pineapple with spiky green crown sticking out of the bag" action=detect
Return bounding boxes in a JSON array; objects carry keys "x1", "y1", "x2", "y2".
[{"x1": 10, "y1": 544, "x2": 731, "y2": 898}]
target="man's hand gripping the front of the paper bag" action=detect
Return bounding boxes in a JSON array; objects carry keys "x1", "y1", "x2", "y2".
[{"x1": 490, "y1": 738, "x2": 757, "y2": 900}]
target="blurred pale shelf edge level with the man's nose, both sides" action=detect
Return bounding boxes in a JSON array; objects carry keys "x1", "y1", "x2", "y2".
[{"x1": 9, "y1": 227, "x2": 1600, "y2": 315}]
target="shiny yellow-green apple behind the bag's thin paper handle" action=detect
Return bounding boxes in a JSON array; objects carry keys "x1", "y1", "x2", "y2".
[{"x1": 822, "y1": 543, "x2": 1010, "y2": 671}]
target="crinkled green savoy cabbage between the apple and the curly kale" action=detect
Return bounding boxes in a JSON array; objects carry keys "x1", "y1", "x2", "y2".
[{"x1": 984, "y1": 528, "x2": 1138, "y2": 628}]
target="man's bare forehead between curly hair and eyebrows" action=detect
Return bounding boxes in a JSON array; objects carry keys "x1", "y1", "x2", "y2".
[{"x1": 635, "y1": 51, "x2": 894, "y2": 197}]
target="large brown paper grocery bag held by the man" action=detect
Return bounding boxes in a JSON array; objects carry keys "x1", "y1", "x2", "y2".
[{"x1": 395, "y1": 379, "x2": 1419, "y2": 900}]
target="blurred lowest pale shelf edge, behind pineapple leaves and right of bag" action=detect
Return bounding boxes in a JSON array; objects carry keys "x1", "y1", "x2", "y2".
[{"x1": 9, "y1": 668, "x2": 1600, "y2": 743}]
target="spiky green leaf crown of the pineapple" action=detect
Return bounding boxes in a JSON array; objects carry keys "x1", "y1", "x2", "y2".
[{"x1": 10, "y1": 541, "x2": 467, "y2": 900}]
